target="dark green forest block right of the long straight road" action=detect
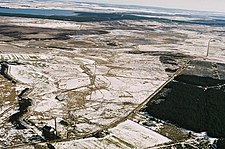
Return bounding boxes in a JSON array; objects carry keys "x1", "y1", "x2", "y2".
[{"x1": 145, "y1": 61, "x2": 225, "y2": 138}]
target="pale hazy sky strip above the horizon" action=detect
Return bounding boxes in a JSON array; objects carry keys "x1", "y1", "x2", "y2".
[{"x1": 77, "y1": 0, "x2": 225, "y2": 12}]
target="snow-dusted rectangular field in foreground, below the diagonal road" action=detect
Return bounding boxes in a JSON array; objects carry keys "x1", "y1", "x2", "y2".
[{"x1": 53, "y1": 120, "x2": 171, "y2": 149}]
